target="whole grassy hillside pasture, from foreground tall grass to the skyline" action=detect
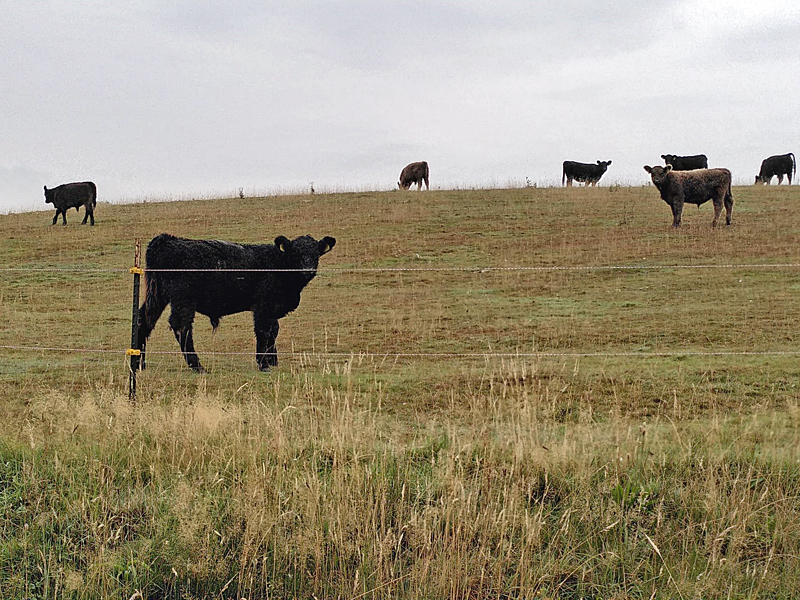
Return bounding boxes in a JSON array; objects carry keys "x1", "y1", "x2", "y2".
[{"x1": 0, "y1": 186, "x2": 800, "y2": 599}]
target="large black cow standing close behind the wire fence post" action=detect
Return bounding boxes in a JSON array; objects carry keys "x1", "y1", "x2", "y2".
[{"x1": 138, "y1": 233, "x2": 336, "y2": 373}]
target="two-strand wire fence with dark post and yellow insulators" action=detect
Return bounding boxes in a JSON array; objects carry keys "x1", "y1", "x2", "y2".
[{"x1": 0, "y1": 239, "x2": 800, "y2": 401}]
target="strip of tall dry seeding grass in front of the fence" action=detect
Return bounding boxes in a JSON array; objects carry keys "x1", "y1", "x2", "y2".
[{"x1": 6, "y1": 362, "x2": 800, "y2": 598}]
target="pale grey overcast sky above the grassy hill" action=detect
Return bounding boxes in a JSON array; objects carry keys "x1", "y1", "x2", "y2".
[{"x1": 0, "y1": 0, "x2": 800, "y2": 212}]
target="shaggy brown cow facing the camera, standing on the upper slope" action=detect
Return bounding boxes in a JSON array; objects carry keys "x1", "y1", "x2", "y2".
[{"x1": 644, "y1": 165, "x2": 733, "y2": 227}]
